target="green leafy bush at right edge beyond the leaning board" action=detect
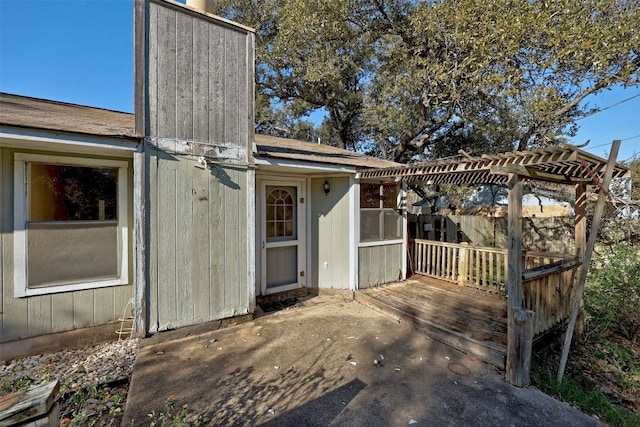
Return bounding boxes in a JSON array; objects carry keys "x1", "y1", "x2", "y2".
[{"x1": 585, "y1": 241, "x2": 640, "y2": 343}]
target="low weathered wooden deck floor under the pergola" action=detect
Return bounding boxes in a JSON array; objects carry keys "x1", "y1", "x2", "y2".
[{"x1": 356, "y1": 275, "x2": 507, "y2": 369}]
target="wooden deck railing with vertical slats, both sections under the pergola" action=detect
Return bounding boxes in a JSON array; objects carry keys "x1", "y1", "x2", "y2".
[{"x1": 410, "y1": 239, "x2": 580, "y2": 335}]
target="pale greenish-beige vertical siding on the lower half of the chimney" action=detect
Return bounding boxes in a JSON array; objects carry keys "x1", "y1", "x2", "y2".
[{"x1": 147, "y1": 148, "x2": 253, "y2": 332}]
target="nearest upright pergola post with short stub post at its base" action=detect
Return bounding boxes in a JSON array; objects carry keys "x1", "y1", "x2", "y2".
[{"x1": 506, "y1": 173, "x2": 534, "y2": 387}]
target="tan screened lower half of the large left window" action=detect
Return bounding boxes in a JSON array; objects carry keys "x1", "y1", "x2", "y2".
[{"x1": 27, "y1": 221, "x2": 119, "y2": 288}]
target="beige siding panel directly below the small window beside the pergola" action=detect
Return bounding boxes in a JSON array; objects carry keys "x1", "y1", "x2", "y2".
[{"x1": 358, "y1": 243, "x2": 402, "y2": 289}]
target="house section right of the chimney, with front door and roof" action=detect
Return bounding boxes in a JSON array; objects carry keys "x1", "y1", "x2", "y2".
[{"x1": 255, "y1": 135, "x2": 407, "y2": 295}]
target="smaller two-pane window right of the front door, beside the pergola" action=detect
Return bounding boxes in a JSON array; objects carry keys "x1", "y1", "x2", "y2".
[{"x1": 360, "y1": 182, "x2": 402, "y2": 242}]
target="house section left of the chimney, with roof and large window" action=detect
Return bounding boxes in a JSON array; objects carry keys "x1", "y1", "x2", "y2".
[{"x1": 0, "y1": 94, "x2": 140, "y2": 350}]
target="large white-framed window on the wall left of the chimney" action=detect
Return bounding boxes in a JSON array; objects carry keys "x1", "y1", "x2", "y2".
[{"x1": 14, "y1": 154, "x2": 128, "y2": 296}]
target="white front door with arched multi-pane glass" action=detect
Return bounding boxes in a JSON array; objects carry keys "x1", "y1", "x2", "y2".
[{"x1": 260, "y1": 180, "x2": 306, "y2": 295}]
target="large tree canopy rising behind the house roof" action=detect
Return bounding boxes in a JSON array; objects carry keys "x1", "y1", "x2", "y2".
[{"x1": 209, "y1": 0, "x2": 640, "y2": 161}]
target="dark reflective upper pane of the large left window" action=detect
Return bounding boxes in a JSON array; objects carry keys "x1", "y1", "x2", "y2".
[{"x1": 27, "y1": 163, "x2": 118, "y2": 221}]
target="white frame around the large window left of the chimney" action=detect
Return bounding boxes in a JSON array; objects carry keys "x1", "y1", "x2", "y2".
[{"x1": 13, "y1": 153, "x2": 129, "y2": 297}]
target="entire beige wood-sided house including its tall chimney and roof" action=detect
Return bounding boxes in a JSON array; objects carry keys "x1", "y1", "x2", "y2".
[{"x1": 0, "y1": 0, "x2": 407, "y2": 359}]
